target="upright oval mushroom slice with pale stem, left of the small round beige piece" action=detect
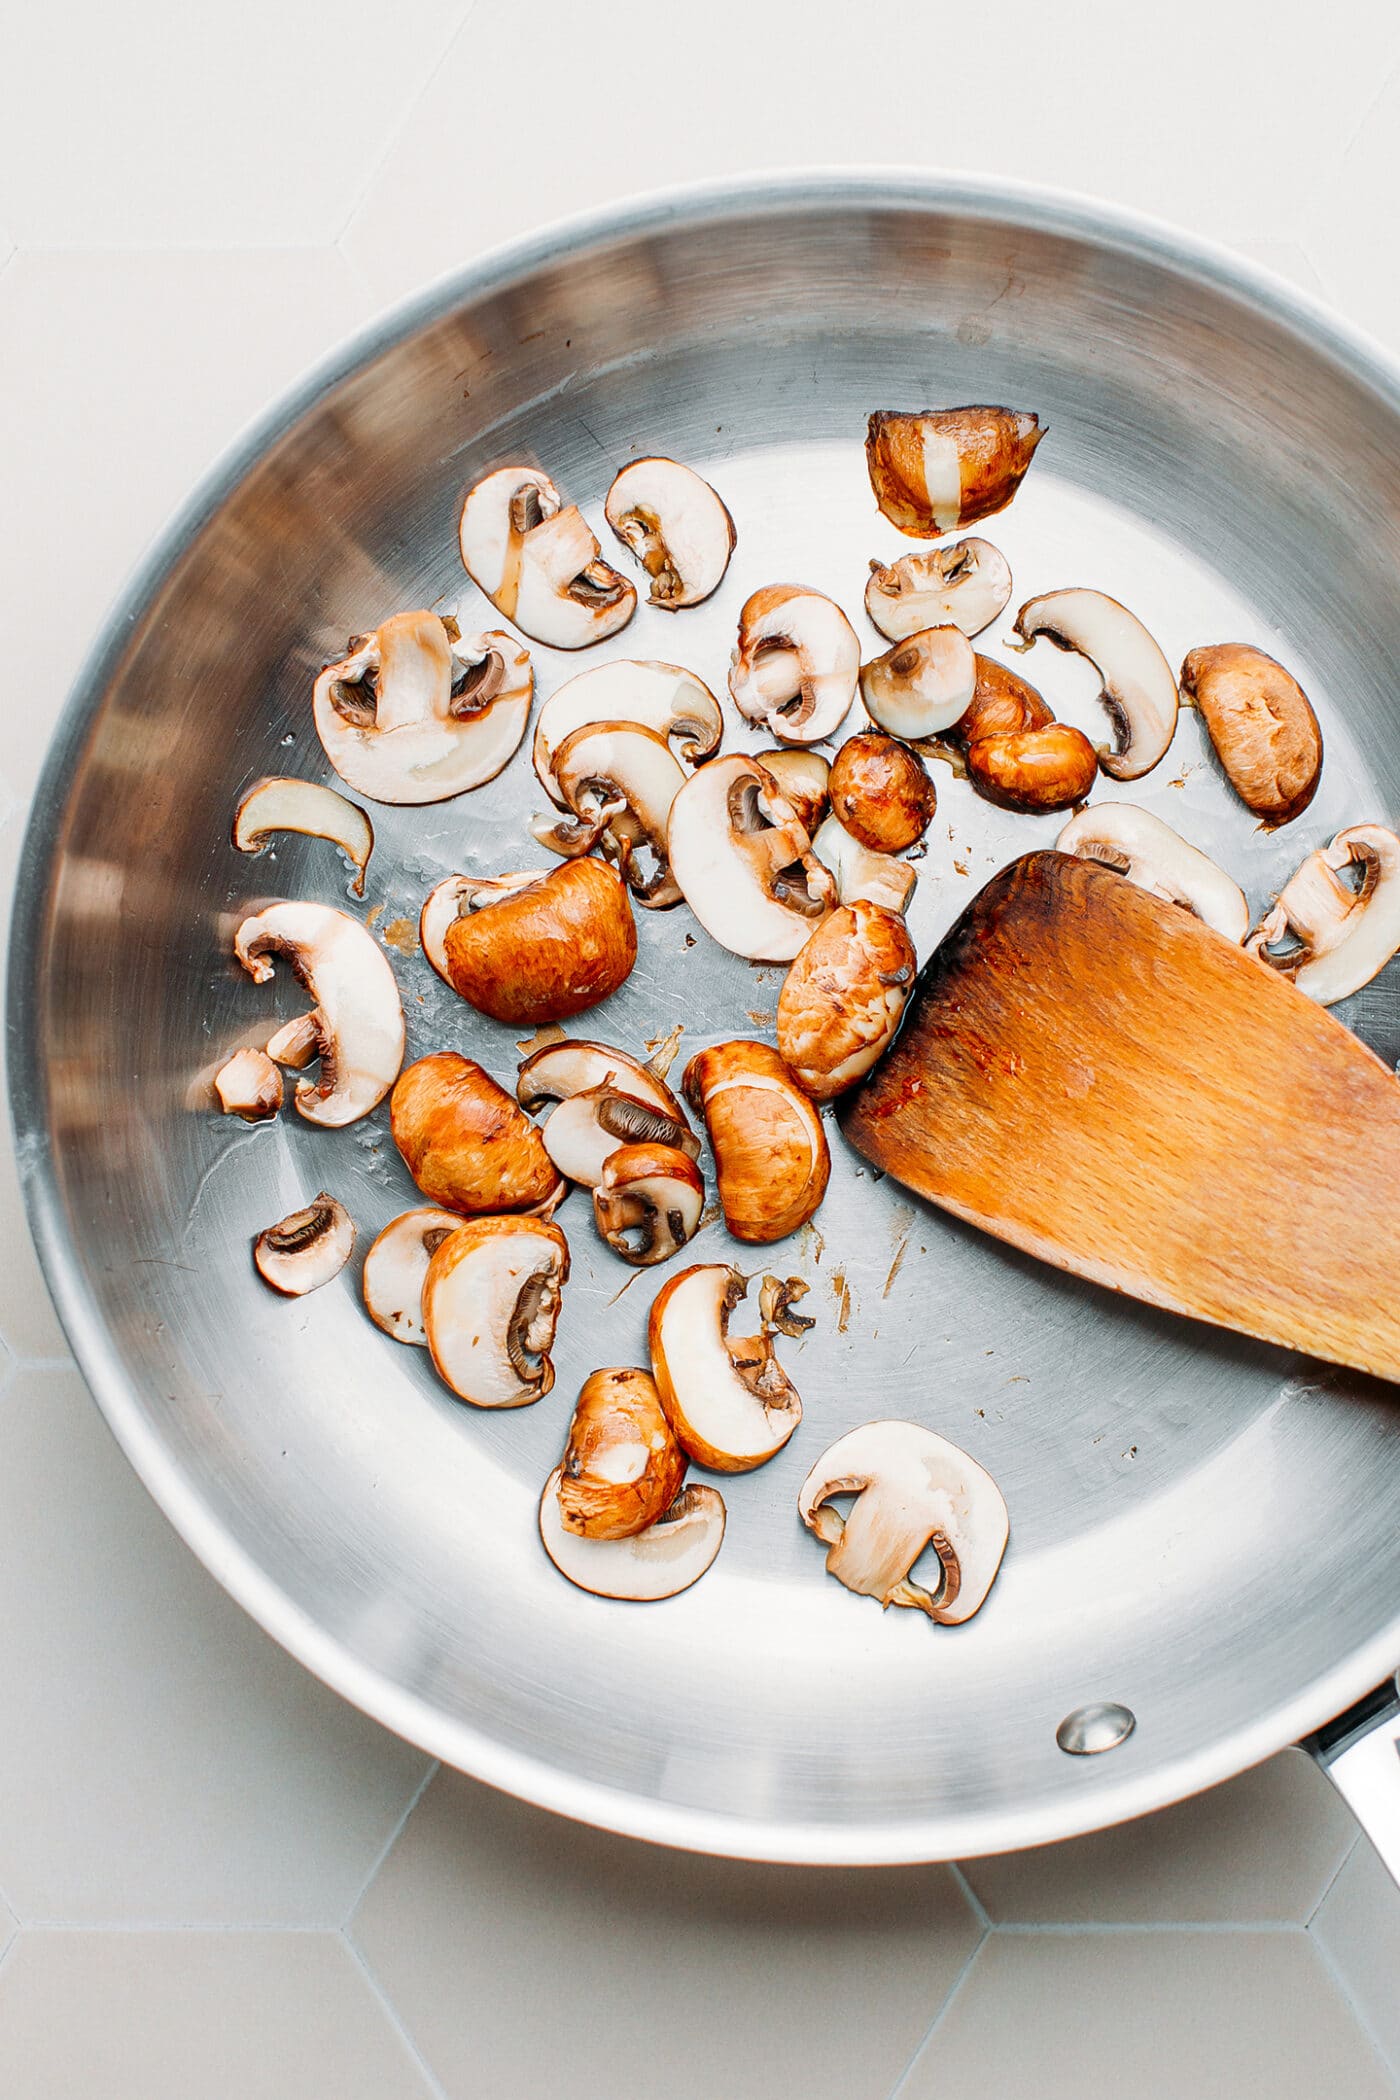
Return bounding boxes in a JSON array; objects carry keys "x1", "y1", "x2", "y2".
[{"x1": 728, "y1": 584, "x2": 861, "y2": 743}]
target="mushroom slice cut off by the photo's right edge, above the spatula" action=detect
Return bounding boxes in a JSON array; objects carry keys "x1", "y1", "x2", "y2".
[{"x1": 1245, "y1": 823, "x2": 1400, "y2": 1006}]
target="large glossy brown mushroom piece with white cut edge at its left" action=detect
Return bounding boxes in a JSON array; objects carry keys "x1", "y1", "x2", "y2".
[{"x1": 418, "y1": 861, "x2": 636, "y2": 1027}]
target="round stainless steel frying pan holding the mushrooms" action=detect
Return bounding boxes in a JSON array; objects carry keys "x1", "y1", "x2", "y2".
[{"x1": 8, "y1": 176, "x2": 1400, "y2": 1861}]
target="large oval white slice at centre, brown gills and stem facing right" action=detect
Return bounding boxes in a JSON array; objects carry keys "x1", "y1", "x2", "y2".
[{"x1": 667, "y1": 756, "x2": 835, "y2": 962}]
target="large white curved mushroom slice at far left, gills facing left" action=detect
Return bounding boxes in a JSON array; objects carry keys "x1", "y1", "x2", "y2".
[{"x1": 233, "y1": 903, "x2": 403, "y2": 1130}]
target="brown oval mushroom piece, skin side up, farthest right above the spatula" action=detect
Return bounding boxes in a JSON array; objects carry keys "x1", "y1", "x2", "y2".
[{"x1": 1182, "y1": 643, "x2": 1322, "y2": 825}]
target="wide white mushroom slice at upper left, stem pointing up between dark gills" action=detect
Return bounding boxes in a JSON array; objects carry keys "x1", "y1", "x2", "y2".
[{"x1": 313, "y1": 611, "x2": 535, "y2": 806}]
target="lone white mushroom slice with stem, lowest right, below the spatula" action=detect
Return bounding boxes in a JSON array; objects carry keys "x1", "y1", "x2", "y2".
[{"x1": 798, "y1": 1422, "x2": 1010, "y2": 1625}]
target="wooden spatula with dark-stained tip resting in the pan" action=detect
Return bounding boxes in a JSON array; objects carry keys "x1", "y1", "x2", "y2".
[{"x1": 842, "y1": 853, "x2": 1400, "y2": 1380}]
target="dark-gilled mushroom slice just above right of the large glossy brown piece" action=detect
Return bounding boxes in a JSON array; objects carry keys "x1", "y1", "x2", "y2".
[{"x1": 531, "y1": 722, "x2": 684, "y2": 911}]
